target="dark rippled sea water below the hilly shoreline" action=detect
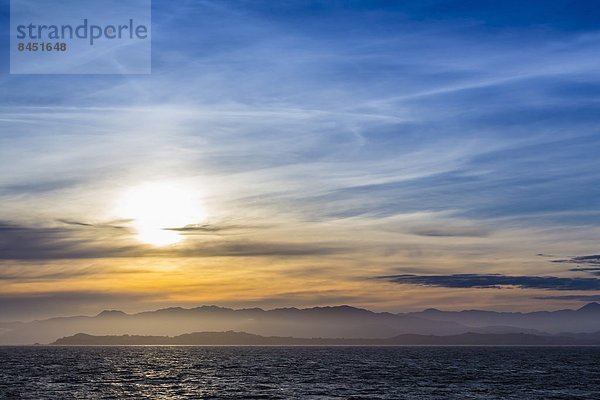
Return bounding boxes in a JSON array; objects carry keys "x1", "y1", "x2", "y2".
[{"x1": 0, "y1": 347, "x2": 600, "y2": 400}]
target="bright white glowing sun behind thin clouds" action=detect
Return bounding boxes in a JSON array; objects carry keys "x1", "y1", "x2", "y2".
[{"x1": 117, "y1": 183, "x2": 205, "y2": 246}]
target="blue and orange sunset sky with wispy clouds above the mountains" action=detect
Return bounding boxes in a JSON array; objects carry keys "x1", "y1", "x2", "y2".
[{"x1": 0, "y1": 0, "x2": 600, "y2": 321}]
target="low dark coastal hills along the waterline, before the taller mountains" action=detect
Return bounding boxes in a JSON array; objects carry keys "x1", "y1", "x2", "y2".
[{"x1": 52, "y1": 331, "x2": 600, "y2": 346}]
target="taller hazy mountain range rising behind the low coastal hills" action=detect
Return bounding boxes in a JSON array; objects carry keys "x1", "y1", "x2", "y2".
[{"x1": 0, "y1": 303, "x2": 600, "y2": 344}]
